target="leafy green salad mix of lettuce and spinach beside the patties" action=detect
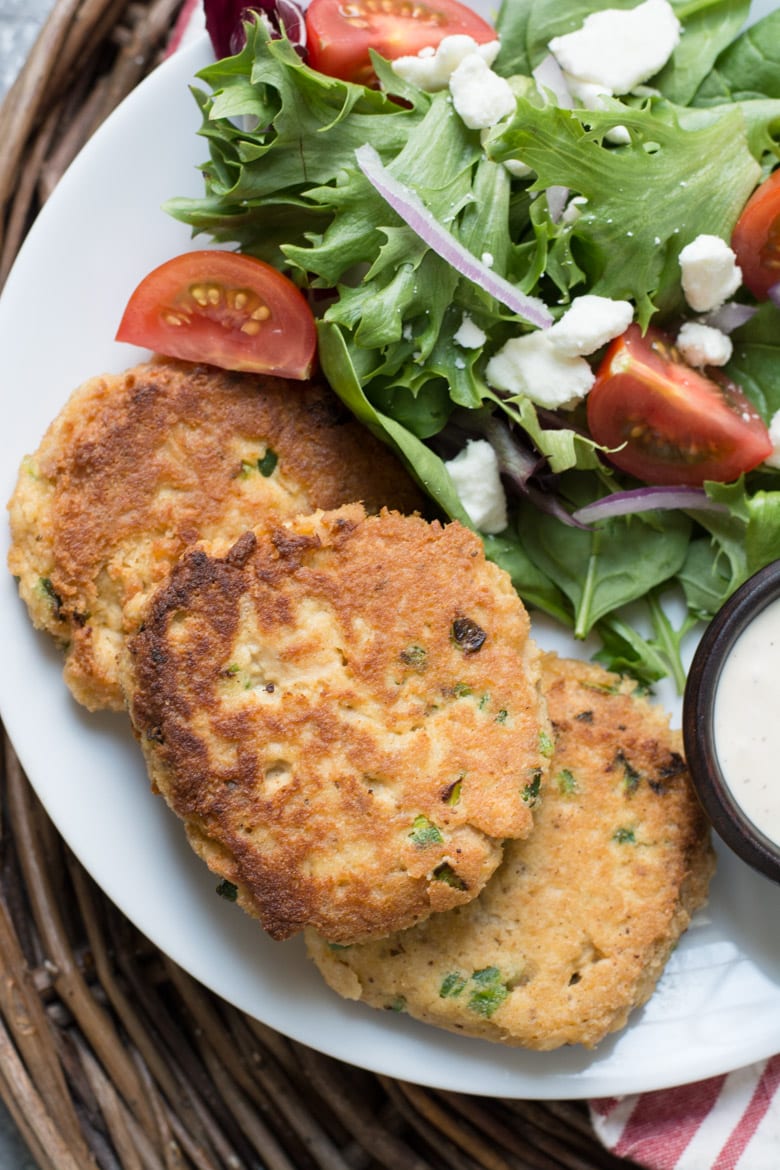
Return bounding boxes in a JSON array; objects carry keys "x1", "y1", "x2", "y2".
[{"x1": 167, "y1": 0, "x2": 780, "y2": 687}]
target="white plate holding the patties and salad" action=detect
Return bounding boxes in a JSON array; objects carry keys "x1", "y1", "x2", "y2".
[{"x1": 0, "y1": 6, "x2": 780, "y2": 1099}]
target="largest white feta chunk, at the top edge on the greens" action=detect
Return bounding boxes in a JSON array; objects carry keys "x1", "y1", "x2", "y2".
[{"x1": 550, "y1": 0, "x2": 681, "y2": 94}]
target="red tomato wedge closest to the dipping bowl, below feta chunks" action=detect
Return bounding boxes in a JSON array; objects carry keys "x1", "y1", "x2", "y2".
[{"x1": 587, "y1": 325, "x2": 773, "y2": 484}]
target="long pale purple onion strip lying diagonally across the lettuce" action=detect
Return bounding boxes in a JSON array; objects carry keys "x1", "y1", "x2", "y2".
[{"x1": 354, "y1": 143, "x2": 553, "y2": 329}]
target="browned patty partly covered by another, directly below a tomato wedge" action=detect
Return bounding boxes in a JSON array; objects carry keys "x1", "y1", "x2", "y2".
[{"x1": 9, "y1": 362, "x2": 422, "y2": 709}]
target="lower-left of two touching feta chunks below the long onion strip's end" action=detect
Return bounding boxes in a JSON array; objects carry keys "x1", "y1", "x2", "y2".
[{"x1": 485, "y1": 330, "x2": 595, "y2": 410}]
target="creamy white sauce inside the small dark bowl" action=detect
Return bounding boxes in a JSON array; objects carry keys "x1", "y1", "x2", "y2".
[{"x1": 713, "y1": 599, "x2": 780, "y2": 845}]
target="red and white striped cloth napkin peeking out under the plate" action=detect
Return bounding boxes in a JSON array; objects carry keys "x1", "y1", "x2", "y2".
[{"x1": 161, "y1": 0, "x2": 780, "y2": 1170}]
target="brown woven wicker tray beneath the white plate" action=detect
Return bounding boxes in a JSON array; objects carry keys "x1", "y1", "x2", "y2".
[{"x1": 0, "y1": 0, "x2": 645, "y2": 1170}]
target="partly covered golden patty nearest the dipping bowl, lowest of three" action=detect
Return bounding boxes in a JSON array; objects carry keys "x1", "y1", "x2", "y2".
[{"x1": 306, "y1": 655, "x2": 713, "y2": 1049}]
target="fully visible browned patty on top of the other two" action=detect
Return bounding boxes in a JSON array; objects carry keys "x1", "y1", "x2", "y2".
[{"x1": 126, "y1": 504, "x2": 550, "y2": 943}]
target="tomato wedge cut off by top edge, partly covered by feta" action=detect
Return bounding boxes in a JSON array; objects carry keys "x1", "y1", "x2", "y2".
[{"x1": 306, "y1": 0, "x2": 496, "y2": 85}]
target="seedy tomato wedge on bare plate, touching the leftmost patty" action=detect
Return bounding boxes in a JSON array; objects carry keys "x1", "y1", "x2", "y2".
[{"x1": 117, "y1": 249, "x2": 317, "y2": 379}]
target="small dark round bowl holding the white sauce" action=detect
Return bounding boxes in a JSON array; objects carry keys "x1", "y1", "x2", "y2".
[{"x1": 683, "y1": 560, "x2": 780, "y2": 883}]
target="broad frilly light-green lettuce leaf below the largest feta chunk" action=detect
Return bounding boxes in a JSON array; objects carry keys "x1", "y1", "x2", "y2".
[{"x1": 490, "y1": 99, "x2": 760, "y2": 326}]
